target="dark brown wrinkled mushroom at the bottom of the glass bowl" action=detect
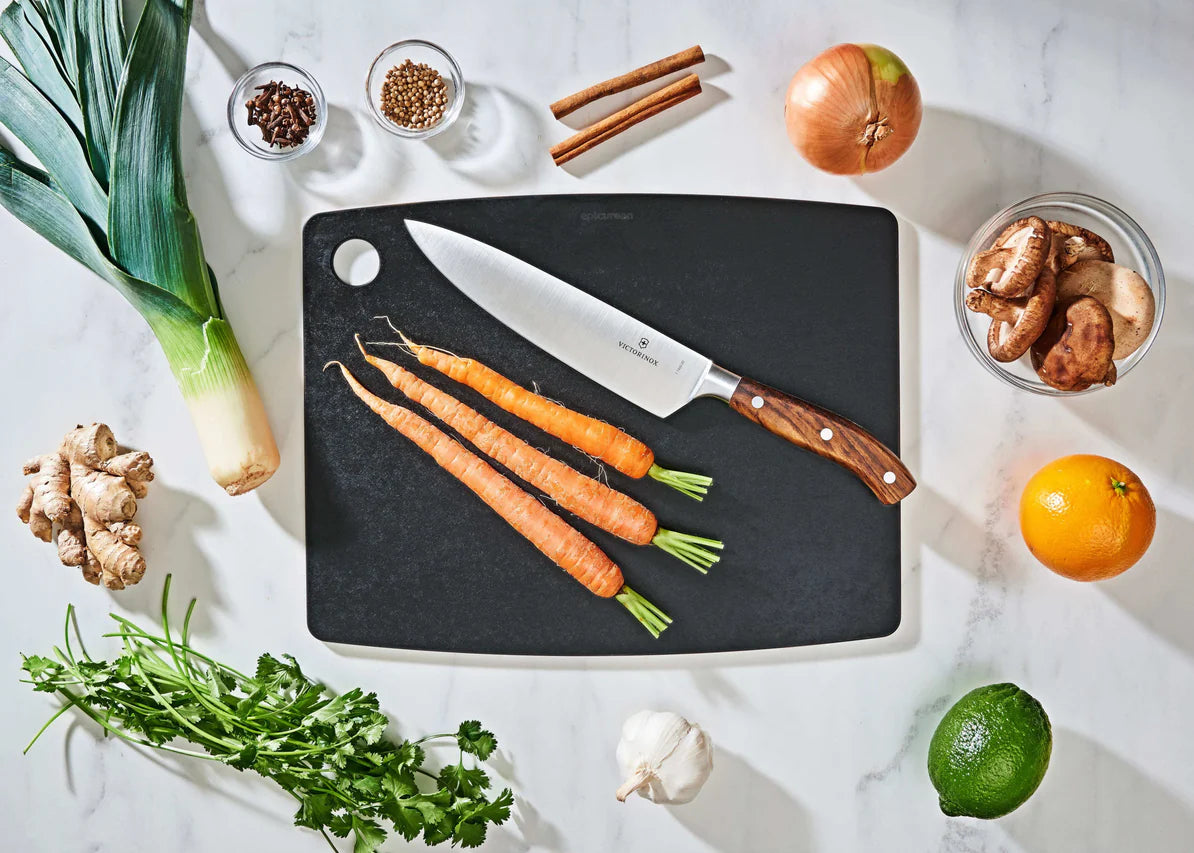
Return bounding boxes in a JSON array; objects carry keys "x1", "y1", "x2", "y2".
[{"x1": 1032, "y1": 296, "x2": 1115, "y2": 391}]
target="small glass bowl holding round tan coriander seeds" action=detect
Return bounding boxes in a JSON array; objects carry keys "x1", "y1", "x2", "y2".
[{"x1": 365, "y1": 38, "x2": 464, "y2": 140}]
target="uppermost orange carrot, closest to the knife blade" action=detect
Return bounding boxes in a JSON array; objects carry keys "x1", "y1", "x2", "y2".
[{"x1": 389, "y1": 324, "x2": 713, "y2": 501}]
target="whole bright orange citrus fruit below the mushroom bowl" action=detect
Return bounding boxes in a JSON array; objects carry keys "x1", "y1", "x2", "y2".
[{"x1": 1020, "y1": 454, "x2": 1157, "y2": 581}]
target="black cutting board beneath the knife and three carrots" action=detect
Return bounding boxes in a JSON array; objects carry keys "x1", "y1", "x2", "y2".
[{"x1": 303, "y1": 195, "x2": 900, "y2": 655}]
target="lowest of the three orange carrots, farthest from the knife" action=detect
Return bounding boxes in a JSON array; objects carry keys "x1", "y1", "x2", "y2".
[{"x1": 324, "y1": 362, "x2": 671, "y2": 637}]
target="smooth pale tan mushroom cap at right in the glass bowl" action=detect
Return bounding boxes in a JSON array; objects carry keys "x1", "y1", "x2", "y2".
[{"x1": 1057, "y1": 255, "x2": 1157, "y2": 361}]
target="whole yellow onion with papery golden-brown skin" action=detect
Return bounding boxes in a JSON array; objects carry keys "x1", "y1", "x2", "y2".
[{"x1": 783, "y1": 44, "x2": 921, "y2": 174}]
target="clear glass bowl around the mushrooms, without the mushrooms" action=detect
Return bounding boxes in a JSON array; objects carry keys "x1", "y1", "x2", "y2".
[{"x1": 954, "y1": 192, "x2": 1165, "y2": 397}]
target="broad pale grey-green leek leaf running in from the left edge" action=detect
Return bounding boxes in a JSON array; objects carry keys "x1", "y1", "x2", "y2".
[{"x1": 0, "y1": 57, "x2": 107, "y2": 231}]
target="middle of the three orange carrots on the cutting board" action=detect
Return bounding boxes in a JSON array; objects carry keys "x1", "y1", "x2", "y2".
[{"x1": 356, "y1": 335, "x2": 721, "y2": 573}]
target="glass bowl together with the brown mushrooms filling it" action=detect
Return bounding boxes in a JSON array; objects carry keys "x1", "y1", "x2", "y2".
[{"x1": 954, "y1": 192, "x2": 1165, "y2": 397}]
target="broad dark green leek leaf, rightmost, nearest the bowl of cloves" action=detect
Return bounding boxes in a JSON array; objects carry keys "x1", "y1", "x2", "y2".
[{"x1": 109, "y1": 0, "x2": 219, "y2": 315}]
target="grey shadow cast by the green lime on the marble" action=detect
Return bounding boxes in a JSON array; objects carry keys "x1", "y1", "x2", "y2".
[{"x1": 999, "y1": 729, "x2": 1194, "y2": 853}]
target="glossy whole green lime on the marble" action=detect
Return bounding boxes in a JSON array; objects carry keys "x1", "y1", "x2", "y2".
[{"x1": 929, "y1": 685, "x2": 1053, "y2": 818}]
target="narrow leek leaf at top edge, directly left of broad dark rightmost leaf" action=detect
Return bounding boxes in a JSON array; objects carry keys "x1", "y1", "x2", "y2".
[{"x1": 75, "y1": 0, "x2": 124, "y2": 186}]
